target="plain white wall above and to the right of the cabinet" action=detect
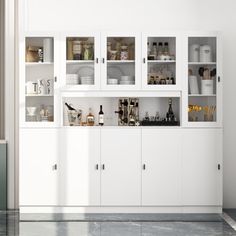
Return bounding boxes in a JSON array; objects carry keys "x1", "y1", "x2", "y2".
[{"x1": 19, "y1": 0, "x2": 236, "y2": 208}]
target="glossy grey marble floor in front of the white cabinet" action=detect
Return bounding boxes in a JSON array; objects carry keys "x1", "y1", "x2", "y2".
[{"x1": 0, "y1": 212, "x2": 236, "y2": 236}]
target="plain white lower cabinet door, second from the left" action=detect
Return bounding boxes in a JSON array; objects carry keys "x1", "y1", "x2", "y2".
[{"x1": 60, "y1": 127, "x2": 100, "y2": 206}]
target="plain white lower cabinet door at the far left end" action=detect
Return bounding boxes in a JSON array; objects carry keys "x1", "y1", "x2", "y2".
[{"x1": 20, "y1": 128, "x2": 60, "y2": 206}]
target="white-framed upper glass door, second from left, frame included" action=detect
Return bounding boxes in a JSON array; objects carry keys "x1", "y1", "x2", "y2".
[{"x1": 61, "y1": 32, "x2": 100, "y2": 90}]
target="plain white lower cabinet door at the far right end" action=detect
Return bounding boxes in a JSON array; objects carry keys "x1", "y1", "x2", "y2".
[{"x1": 182, "y1": 129, "x2": 222, "y2": 206}]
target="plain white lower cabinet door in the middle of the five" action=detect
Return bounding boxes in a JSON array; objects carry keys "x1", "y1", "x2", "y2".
[{"x1": 101, "y1": 127, "x2": 141, "y2": 206}]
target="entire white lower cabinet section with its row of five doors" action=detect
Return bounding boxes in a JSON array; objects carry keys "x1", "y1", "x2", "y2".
[{"x1": 20, "y1": 127, "x2": 222, "y2": 207}]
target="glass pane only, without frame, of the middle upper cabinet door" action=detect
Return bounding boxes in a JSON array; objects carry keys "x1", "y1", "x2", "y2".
[{"x1": 107, "y1": 37, "x2": 135, "y2": 85}]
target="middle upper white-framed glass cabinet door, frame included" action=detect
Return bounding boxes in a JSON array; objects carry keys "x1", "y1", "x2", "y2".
[{"x1": 101, "y1": 33, "x2": 141, "y2": 90}]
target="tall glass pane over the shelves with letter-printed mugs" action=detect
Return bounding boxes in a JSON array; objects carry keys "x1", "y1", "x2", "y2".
[{"x1": 25, "y1": 37, "x2": 54, "y2": 122}]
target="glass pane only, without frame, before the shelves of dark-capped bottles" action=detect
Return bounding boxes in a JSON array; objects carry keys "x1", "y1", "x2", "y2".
[{"x1": 147, "y1": 37, "x2": 176, "y2": 85}]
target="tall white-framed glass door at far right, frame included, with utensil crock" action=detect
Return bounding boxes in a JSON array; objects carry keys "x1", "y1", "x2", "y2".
[{"x1": 186, "y1": 32, "x2": 222, "y2": 126}]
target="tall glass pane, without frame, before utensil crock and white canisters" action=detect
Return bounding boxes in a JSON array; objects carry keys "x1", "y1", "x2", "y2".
[{"x1": 188, "y1": 37, "x2": 217, "y2": 122}]
